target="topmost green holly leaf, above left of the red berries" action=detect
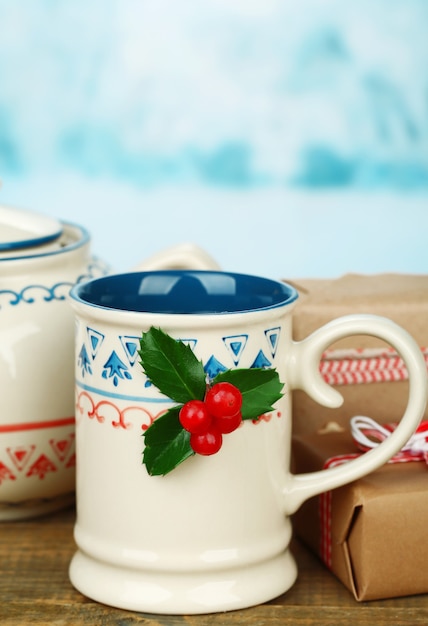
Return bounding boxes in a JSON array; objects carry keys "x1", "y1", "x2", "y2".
[{"x1": 138, "y1": 326, "x2": 206, "y2": 403}]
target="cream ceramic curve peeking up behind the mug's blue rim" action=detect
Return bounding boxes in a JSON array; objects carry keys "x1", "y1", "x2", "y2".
[{"x1": 131, "y1": 243, "x2": 220, "y2": 272}]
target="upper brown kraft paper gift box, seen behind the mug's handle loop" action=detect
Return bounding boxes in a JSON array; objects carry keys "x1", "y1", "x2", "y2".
[{"x1": 287, "y1": 274, "x2": 428, "y2": 433}]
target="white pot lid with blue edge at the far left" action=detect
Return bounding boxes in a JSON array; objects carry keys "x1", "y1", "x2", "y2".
[{"x1": 0, "y1": 206, "x2": 62, "y2": 252}]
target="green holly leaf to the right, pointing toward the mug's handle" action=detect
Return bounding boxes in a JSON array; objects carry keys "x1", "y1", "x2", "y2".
[{"x1": 212, "y1": 368, "x2": 284, "y2": 420}]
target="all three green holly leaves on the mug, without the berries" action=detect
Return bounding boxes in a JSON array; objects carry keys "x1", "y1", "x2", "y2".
[{"x1": 138, "y1": 326, "x2": 283, "y2": 476}]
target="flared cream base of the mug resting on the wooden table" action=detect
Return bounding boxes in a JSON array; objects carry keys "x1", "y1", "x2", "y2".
[{"x1": 69, "y1": 550, "x2": 297, "y2": 615}]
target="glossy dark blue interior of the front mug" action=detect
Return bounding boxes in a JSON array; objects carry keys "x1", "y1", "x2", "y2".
[{"x1": 71, "y1": 270, "x2": 297, "y2": 315}]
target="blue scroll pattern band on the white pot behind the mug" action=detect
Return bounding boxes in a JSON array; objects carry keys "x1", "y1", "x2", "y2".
[{"x1": 0, "y1": 260, "x2": 107, "y2": 310}]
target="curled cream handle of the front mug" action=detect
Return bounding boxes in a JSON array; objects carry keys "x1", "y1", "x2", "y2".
[{"x1": 284, "y1": 314, "x2": 428, "y2": 515}]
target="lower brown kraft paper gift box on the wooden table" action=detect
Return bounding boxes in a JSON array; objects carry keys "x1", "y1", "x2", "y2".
[{"x1": 293, "y1": 431, "x2": 428, "y2": 601}]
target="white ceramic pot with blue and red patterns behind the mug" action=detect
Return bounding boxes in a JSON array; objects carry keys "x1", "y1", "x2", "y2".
[{"x1": 0, "y1": 207, "x2": 215, "y2": 520}]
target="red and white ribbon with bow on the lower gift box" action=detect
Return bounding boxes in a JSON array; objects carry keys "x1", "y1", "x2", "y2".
[{"x1": 319, "y1": 415, "x2": 428, "y2": 568}]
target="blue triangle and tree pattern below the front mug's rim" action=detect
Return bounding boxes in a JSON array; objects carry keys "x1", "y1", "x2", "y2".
[{"x1": 77, "y1": 326, "x2": 281, "y2": 387}]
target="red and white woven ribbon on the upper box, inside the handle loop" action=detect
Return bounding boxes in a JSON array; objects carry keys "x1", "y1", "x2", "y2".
[{"x1": 320, "y1": 348, "x2": 428, "y2": 385}]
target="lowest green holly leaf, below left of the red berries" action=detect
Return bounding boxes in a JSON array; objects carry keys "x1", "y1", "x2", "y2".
[{"x1": 143, "y1": 406, "x2": 195, "y2": 476}]
